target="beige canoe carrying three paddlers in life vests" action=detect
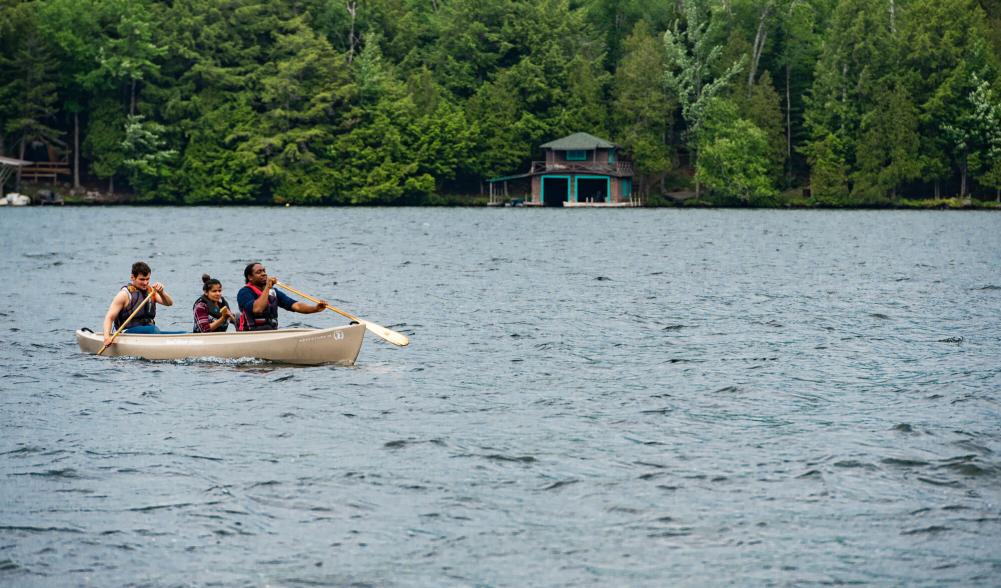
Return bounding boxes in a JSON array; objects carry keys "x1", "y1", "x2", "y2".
[{"x1": 76, "y1": 325, "x2": 365, "y2": 366}]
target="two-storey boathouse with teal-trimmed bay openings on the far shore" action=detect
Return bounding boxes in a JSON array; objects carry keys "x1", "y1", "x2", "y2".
[{"x1": 487, "y1": 132, "x2": 639, "y2": 206}]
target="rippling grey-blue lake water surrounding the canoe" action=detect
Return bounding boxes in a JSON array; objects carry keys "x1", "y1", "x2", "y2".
[{"x1": 0, "y1": 207, "x2": 1001, "y2": 586}]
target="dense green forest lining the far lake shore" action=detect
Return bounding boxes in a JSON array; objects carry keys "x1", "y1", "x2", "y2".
[{"x1": 0, "y1": 0, "x2": 1001, "y2": 206}]
